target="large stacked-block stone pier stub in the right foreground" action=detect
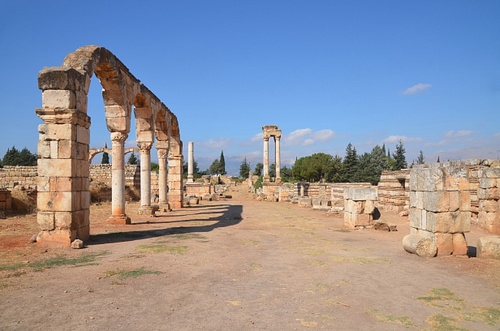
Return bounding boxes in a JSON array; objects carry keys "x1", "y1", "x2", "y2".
[{"x1": 410, "y1": 161, "x2": 471, "y2": 256}]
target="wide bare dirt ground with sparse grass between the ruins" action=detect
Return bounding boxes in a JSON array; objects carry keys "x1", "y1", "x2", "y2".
[{"x1": 0, "y1": 186, "x2": 500, "y2": 330}]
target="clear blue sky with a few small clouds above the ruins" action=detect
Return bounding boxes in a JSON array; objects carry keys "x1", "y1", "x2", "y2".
[{"x1": 0, "y1": 0, "x2": 500, "y2": 175}]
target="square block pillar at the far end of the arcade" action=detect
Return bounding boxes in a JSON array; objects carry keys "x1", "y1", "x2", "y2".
[{"x1": 168, "y1": 142, "x2": 183, "y2": 209}]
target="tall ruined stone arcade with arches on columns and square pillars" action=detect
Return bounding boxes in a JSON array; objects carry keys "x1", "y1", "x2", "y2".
[{"x1": 36, "y1": 46, "x2": 182, "y2": 246}]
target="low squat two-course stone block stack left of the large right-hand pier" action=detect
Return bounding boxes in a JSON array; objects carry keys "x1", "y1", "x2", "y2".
[{"x1": 344, "y1": 187, "x2": 377, "y2": 228}]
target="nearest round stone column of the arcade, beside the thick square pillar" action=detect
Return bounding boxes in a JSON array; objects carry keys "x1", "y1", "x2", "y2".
[{"x1": 108, "y1": 132, "x2": 130, "y2": 224}]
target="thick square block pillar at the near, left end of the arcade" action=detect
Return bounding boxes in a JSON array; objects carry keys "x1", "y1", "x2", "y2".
[{"x1": 36, "y1": 68, "x2": 90, "y2": 247}]
